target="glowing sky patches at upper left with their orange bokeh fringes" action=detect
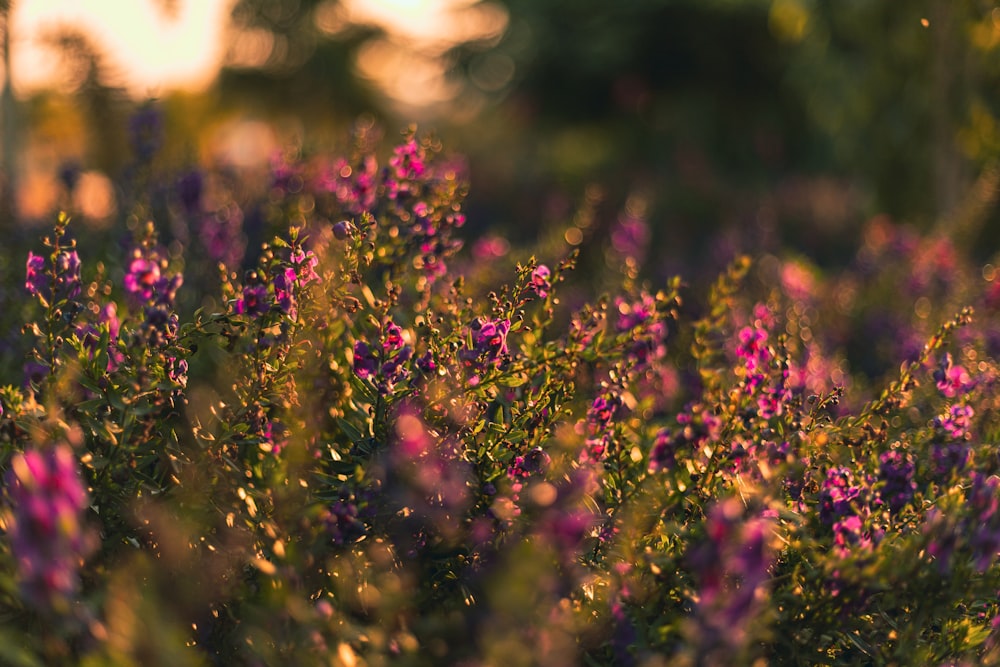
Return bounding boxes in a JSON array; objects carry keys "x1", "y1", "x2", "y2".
[{"x1": 12, "y1": 0, "x2": 507, "y2": 105}]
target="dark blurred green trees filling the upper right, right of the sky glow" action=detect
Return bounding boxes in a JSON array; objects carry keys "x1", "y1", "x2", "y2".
[{"x1": 450, "y1": 0, "x2": 1000, "y2": 272}]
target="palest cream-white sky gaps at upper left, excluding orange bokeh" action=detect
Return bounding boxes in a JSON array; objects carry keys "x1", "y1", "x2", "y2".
[{"x1": 11, "y1": 0, "x2": 492, "y2": 102}]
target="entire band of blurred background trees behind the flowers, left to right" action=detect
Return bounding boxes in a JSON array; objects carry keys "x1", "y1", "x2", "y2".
[{"x1": 11, "y1": 0, "x2": 1000, "y2": 275}]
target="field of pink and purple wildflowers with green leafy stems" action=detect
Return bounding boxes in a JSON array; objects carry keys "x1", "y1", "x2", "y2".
[{"x1": 0, "y1": 117, "x2": 1000, "y2": 667}]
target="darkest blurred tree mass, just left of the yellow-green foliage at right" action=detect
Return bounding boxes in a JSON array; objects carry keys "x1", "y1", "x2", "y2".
[{"x1": 451, "y1": 0, "x2": 829, "y2": 274}]
